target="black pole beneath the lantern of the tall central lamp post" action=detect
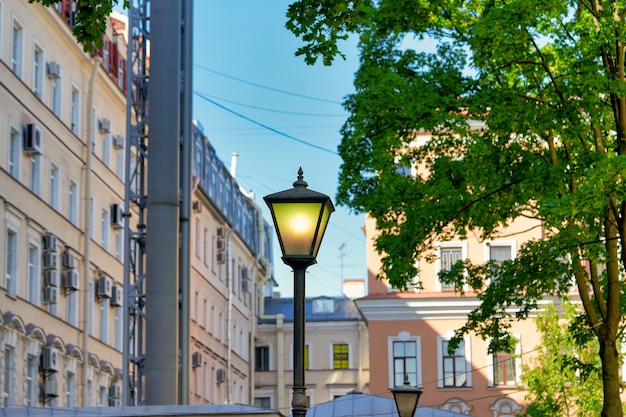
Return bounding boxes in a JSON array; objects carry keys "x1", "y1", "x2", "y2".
[{"x1": 291, "y1": 265, "x2": 309, "y2": 417}]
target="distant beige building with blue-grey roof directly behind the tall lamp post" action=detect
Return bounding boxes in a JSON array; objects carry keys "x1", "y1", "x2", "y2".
[{"x1": 255, "y1": 286, "x2": 370, "y2": 415}]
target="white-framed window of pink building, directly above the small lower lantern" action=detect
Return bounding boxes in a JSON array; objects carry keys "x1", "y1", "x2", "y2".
[{"x1": 390, "y1": 338, "x2": 422, "y2": 387}]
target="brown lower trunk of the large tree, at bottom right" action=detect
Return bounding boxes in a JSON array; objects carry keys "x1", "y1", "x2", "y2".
[{"x1": 599, "y1": 332, "x2": 622, "y2": 417}]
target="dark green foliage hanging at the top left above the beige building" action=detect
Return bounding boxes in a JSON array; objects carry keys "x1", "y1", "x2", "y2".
[{"x1": 28, "y1": 0, "x2": 130, "y2": 52}]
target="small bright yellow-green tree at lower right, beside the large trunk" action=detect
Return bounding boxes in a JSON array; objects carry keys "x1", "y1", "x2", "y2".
[{"x1": 521, "y1": 303, "x2": 602, "y2": 417}]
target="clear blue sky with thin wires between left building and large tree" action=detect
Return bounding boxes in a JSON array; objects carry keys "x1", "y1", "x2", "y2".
[{"x1": 193, "y1": 0, "x2": 367, "y2": 296}]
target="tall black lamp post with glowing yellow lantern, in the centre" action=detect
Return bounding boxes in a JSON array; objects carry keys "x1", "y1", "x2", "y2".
[{"x1": 263, "y1": 168, "x2": 335, "y2": 417}]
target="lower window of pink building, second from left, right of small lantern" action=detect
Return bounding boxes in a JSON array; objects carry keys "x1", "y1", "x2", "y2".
[{"x1": 437, "y1": 336, "x2": 472, "y2": 388}]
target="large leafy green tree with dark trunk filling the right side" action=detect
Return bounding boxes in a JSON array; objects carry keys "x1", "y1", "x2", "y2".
[{"x1": 287, "y1": 0, "x2": 626, "y2": 417}]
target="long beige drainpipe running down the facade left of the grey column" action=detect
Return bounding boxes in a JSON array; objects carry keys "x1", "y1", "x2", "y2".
[{"x1": 81, "y1": 57, "x2": 102, "y2": 407}]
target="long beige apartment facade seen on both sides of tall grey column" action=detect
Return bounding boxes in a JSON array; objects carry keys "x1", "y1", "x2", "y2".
[{"x1": 0, "y1": 0, "x2": 273, "y2": 407}]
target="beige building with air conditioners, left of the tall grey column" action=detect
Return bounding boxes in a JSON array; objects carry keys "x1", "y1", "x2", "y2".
[{"x1": 0, "y1": 1, "x2": 126, "y2": 407}]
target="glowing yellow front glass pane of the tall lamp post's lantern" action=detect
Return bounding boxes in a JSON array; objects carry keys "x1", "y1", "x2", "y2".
[{"x1": 272, "y1": 202, "x2": 322, "y2": 256}]
